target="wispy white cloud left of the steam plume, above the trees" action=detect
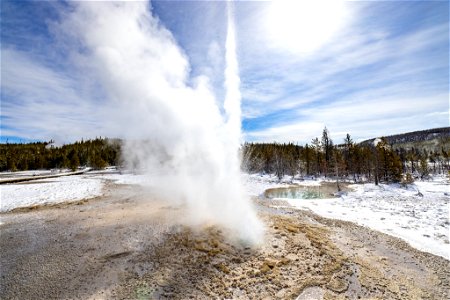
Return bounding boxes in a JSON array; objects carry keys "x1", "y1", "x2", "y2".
[{"x1": 1, "y1": 48, "x2": 110, "y2": 142}]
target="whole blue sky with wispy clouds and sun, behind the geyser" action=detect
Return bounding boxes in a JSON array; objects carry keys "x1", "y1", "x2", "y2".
[{"x1": 1, "y1": 1, "x2": 449, "y2": 144}]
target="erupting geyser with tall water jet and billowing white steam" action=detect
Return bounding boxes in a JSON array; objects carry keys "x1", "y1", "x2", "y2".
[{"x1": 61, "y1": 1, "x2": 263, "y2": 244}]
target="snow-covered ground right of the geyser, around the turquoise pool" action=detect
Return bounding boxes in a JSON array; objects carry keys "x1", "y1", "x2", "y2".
[{"x1": 244, "y1": 175, "x2": 450, "y2": 260}]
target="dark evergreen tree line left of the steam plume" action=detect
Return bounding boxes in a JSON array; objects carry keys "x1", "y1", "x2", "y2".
[{"x1": 0, "y1": 138, "x2": 122, "y2": 171}]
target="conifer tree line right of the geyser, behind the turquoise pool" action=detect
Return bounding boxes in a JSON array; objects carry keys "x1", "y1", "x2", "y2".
[{"x1": 242, "y1": 127, "x2": 450, "y2": 184}]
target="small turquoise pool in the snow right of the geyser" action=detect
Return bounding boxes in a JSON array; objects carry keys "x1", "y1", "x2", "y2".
[{"x1": 264, "y1": 182, "x2": 342, "y2": 199}]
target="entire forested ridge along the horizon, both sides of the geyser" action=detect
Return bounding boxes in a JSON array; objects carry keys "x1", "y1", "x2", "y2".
[{"x1": 0, "y1": 127, "x2": 450, "y2": 184}]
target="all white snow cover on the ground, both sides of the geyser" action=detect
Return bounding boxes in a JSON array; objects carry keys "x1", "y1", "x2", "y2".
[{"x1": 0, "y1": 170, "x2": 450, "y2": 260}]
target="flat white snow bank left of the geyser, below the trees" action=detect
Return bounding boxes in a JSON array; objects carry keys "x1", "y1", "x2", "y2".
[{"x1": 0, "y1": 175, "x2": 103, "y2": 212}]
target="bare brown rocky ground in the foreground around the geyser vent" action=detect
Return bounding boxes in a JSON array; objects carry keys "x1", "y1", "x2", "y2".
[{"x1": 0, "y1": 184, "x2": 450, "y2": 299}]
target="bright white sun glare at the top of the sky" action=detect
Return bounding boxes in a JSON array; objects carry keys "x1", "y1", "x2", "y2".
[{"x1": 264, "y1": 0, "x2": 347, "y2": 53}]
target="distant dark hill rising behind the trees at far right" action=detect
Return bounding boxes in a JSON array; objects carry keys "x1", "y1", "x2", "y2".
[{"x1": 360, "y1": 127, "x2": 450, "y2": 152}]
